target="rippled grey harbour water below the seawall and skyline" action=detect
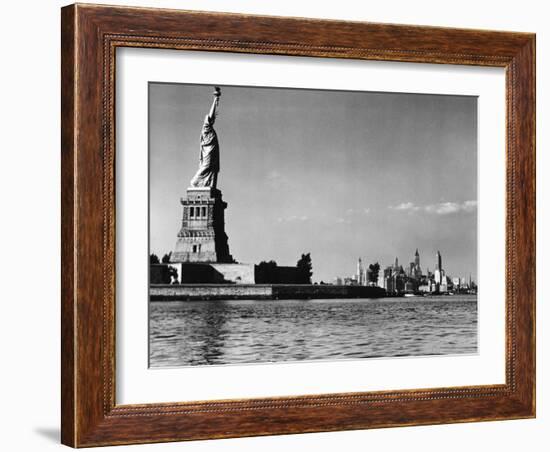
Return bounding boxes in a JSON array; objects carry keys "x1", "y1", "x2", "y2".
[{"x1": 149, "y1": 295, "x2": 477, "y2": 367}]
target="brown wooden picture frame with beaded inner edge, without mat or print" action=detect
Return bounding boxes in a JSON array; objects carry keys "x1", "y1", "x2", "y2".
[{"x1": 61, "y1": 4, "x2": 535, "y2": 447}]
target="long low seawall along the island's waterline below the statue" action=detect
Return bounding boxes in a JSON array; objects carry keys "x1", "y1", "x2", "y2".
[{"x1": 149, "y1": 284, "x2": 386, "y2": 301}]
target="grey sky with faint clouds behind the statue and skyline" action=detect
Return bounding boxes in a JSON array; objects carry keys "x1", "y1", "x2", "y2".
[{"x1": 149, "y1": 83, "x2": 477, "y2": 282}]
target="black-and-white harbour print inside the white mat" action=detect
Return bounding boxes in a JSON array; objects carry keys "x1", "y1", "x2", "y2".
[{"x1": 149, "y1": 83, "x2": 478, "y2": 368}]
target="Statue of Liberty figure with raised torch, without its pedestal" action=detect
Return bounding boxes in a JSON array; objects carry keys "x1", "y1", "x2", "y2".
[{"x1": 191, "y1": 86, "x2": 222, "y2": 188}]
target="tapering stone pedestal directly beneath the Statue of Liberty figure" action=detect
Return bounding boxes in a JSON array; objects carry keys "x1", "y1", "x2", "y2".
[{"x1": 170, "y1": 187, "x2": 234, "y2": 263}]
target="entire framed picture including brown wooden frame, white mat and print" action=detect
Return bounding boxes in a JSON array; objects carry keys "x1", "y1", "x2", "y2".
[{"x1": 61, "y1": 4, "x2": 535, "y2": 447}]
